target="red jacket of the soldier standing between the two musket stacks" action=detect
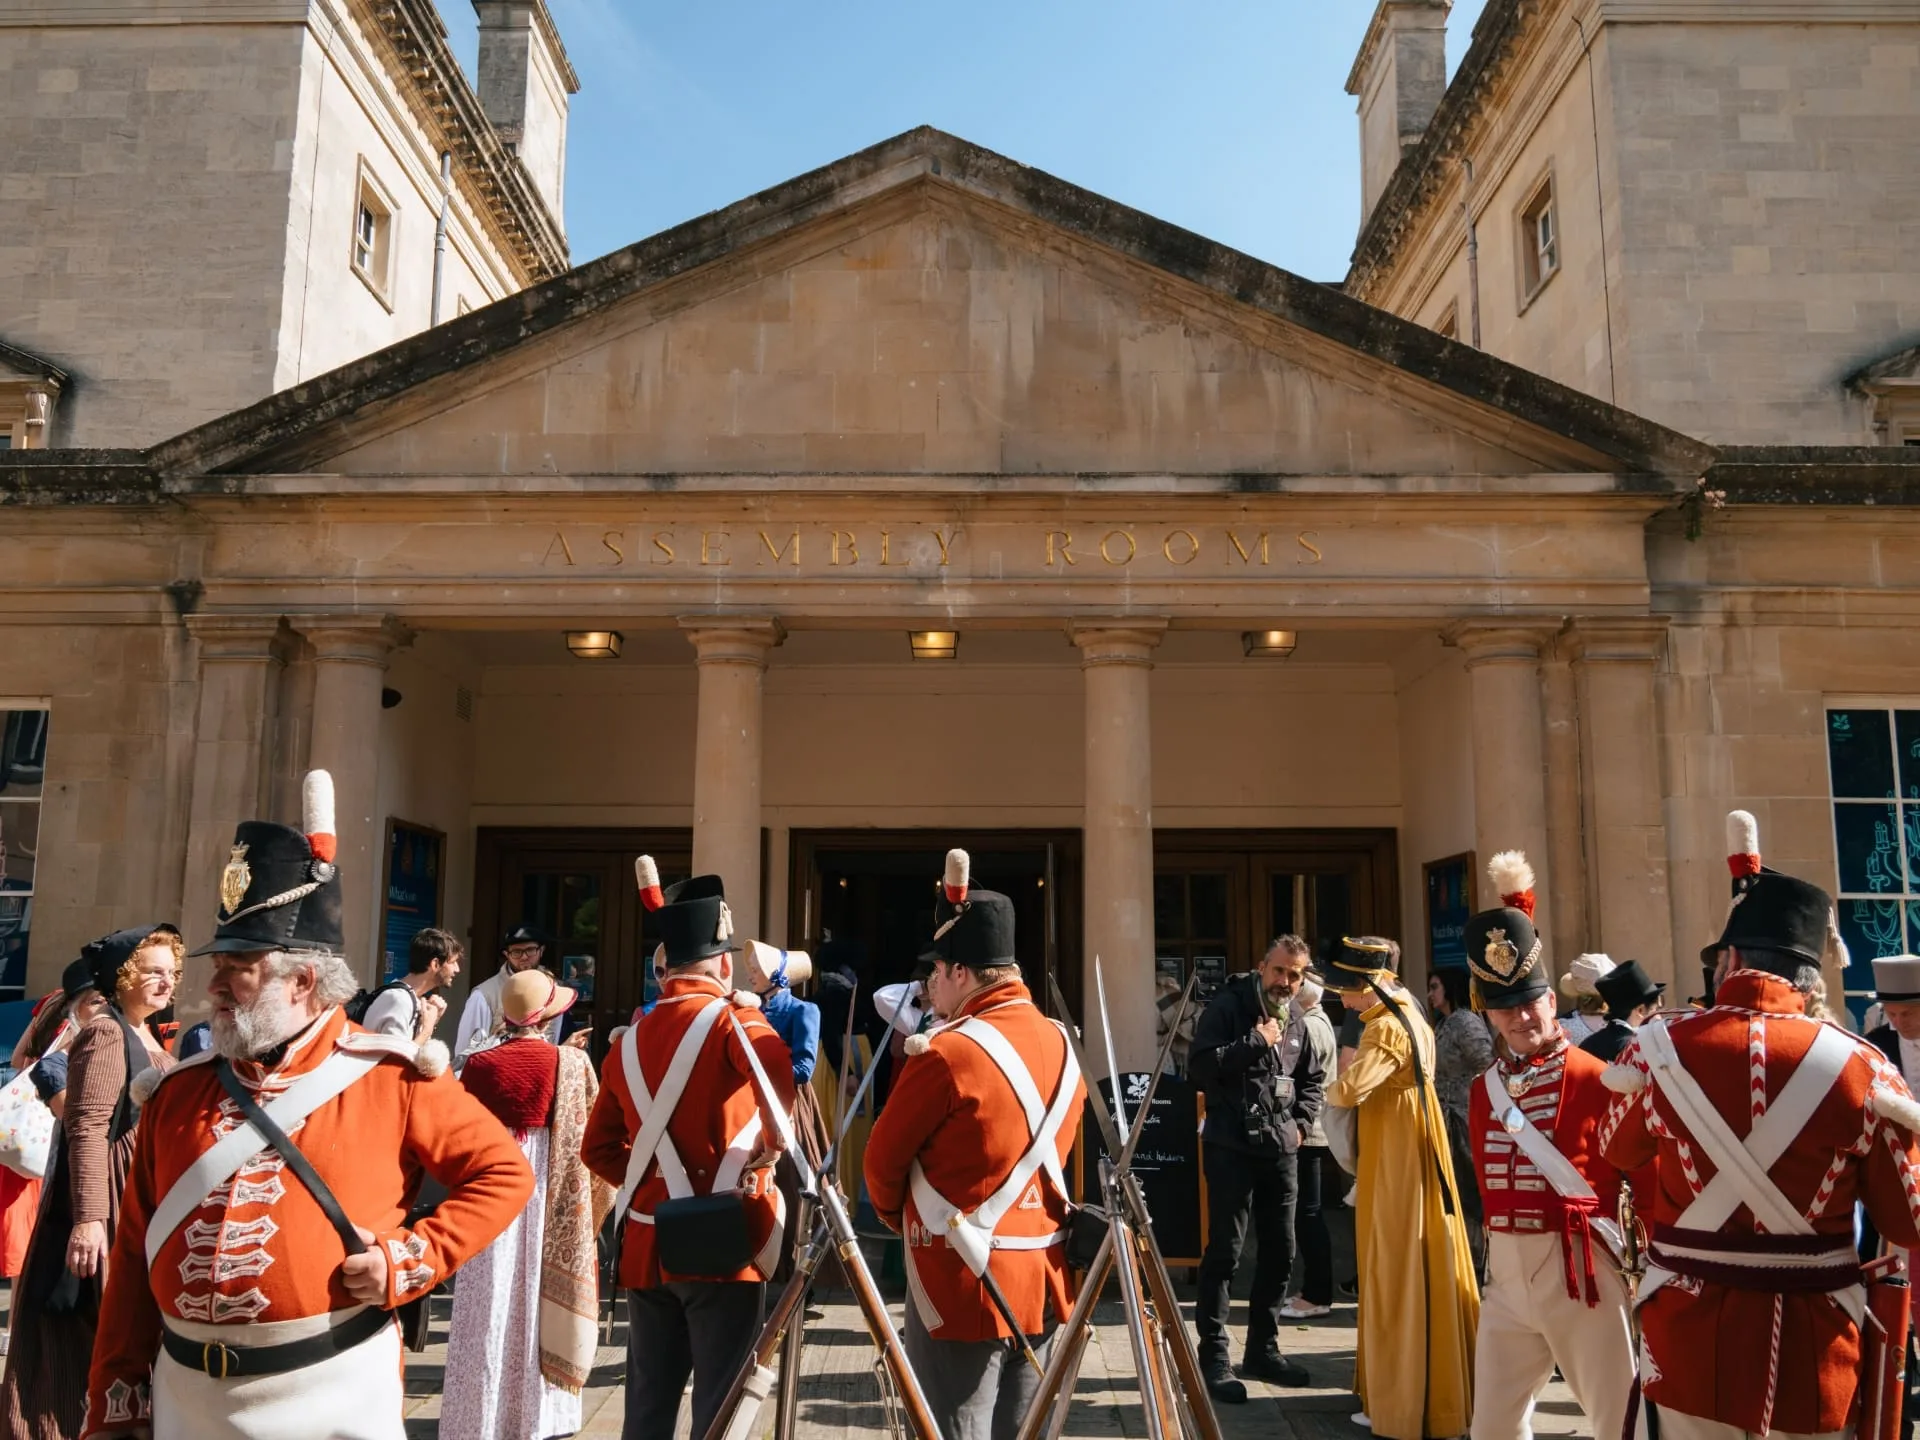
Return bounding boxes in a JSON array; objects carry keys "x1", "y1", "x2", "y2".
[{"x1": 866, "y1": 981, "x2": 1087, "y2": 1340}]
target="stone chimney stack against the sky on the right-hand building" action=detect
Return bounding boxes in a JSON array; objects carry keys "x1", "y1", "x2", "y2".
[{"x1": 1346, "y1": 0, "x2": 1452, "y2": 228}]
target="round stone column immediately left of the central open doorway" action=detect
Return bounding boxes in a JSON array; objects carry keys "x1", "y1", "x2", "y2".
[{"x1": 680, "y1": 616, "x2": 787, "y2": 941}]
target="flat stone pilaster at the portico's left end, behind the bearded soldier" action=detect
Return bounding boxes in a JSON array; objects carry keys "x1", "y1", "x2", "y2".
[{"x1": 177, "y1": 614, "x2": 290, "y2": 1023}]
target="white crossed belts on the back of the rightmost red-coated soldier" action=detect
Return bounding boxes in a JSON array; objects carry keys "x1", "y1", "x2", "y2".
[{"x1": 1638, "y1": 1020, "x2": 1866, "y2": 1325}]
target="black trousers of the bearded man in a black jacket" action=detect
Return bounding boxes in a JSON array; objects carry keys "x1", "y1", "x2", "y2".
[{"x1": 1194, "y1": 1144, "x2": 1298, "y2": 1361}]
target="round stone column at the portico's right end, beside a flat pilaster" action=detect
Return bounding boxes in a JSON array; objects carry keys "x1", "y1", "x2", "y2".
[{"x1": 1448, "y1": 620, "x2": 1559, "y2": 913}]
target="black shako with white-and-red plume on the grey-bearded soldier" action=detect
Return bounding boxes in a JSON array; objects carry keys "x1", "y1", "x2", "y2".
[{"x1": 194, "y1": 770, "x2": 348, "y2": 956}]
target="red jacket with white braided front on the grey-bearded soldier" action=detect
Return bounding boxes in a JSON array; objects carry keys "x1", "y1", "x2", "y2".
[{"x1": 84, "y1": 1008, "x2": 534, "y2": 1436}]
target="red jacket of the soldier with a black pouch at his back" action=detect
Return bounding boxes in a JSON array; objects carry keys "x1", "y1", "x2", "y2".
[{"x1": 580, "y1": 975, "x2": 793, "y2": 1290}]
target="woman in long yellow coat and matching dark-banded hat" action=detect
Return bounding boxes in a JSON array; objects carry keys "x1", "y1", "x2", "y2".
[{"x1": 1327, "y1": 937, "x2": 1480, "y2": 1440}]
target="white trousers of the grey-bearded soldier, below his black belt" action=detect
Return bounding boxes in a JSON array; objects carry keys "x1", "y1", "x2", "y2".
[{"x1": 154, "y1": 1317, "x2": 407, "y2": 1440}]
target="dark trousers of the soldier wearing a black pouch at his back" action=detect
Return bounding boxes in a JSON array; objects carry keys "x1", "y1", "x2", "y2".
[{"x1": 620, "y1": 1281, "x2": 766, "y2": 1440}]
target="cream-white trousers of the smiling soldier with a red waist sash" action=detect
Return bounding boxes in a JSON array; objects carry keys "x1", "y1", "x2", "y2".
[{"x1": 1471, "y1": 1231, "x2": 1635, "y2": 1440}]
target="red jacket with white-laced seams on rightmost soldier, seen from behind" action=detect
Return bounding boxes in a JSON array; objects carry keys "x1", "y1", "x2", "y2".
[{"x1": 1601, "y1": 970, "x2": 1920, "y2": 1434}]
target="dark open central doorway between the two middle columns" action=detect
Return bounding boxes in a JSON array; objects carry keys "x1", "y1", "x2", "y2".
[{"x1": 787, "y1": 829, "x2": 1081, "y2": 1014}]
